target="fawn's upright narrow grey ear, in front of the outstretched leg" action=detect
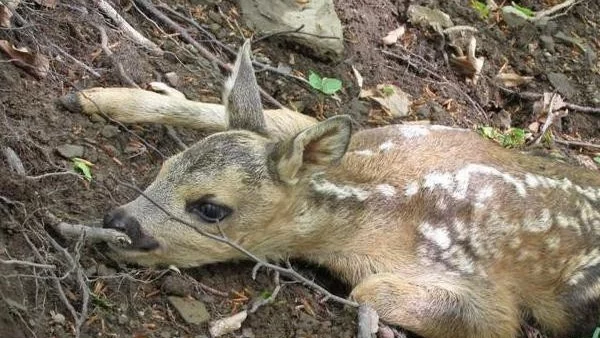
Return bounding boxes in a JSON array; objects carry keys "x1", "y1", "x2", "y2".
[{"x1": 223, "y1": 40, "x2": 266, "y2": 133}]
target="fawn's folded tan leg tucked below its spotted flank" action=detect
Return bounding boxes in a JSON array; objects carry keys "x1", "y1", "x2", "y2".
[{"x1": 351, "y1": 273, "x2": 520, "y2": 338}]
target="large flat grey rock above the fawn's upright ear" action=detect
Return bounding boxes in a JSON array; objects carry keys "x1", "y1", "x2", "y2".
[{"x1": 238, "y1": 0, "x2": 344, "y2": 60}]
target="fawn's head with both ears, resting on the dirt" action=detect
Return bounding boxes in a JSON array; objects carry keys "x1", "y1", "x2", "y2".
[{"x1": 104, "y1": 41, "x2": 351, "y2": 266}]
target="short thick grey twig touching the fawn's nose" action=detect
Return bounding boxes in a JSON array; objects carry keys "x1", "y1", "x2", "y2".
[{"x1": 45, "y1": 211, "x2": 131, "y2": 245}]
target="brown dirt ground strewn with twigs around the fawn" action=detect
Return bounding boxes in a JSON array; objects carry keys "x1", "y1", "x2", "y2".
[{"x1": 0, "y1": 0, "x2": 600, "y2": 338}]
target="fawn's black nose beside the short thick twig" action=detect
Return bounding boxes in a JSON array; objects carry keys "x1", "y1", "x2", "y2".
[{"x1": 104, "y1": 208, "x2": 158, "y2": 251}]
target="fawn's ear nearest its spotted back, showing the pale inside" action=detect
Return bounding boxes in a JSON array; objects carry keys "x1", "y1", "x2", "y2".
[{"x1": 273, "y1": 115, "x2": 352, "y2": 184}]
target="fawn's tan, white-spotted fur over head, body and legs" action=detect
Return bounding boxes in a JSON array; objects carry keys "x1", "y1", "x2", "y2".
[{"x1": 63, "y1": 42, "x2": 600, "y2": 338}]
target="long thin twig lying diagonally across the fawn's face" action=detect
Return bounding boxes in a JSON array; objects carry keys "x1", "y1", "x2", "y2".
[{"x1": 119, "y1": 181, "x2": 358, "y2": 307}]
